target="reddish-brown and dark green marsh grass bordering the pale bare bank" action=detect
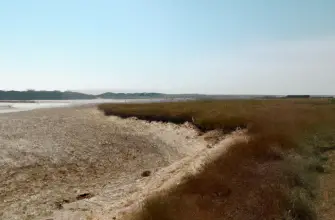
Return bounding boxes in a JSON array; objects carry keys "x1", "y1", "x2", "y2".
[{"x1": 99, "y1": 99, "x2": 335, "y2": 220}]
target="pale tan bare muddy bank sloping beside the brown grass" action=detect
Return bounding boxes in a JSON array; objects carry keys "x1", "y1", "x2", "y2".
[{"x1": 0, "y1": 108, "x2": 247, "y2": 220}]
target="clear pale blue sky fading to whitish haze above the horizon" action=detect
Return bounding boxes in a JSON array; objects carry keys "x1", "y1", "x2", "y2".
[{"x1": 0, "y1": 0, "x2": 335, "y2": 95}]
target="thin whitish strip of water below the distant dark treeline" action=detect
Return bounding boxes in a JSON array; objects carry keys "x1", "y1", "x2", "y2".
[{"x1": 0, "y1": 99, "x2": 186, "y2": 114}]
